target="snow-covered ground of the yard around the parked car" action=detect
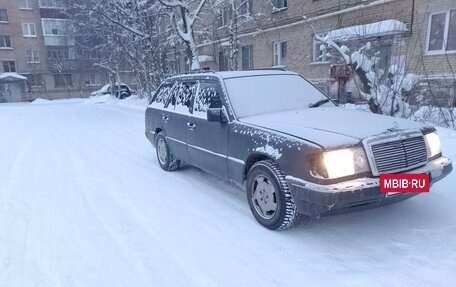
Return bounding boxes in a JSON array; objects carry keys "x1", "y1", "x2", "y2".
[{"x1": 0, "y1": 98, "x2": 456, "y2": 287}]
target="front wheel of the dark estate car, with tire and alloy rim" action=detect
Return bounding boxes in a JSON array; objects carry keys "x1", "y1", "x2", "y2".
[{"x1": 246, "y1": 160, "x2": 298, "y2": 230}]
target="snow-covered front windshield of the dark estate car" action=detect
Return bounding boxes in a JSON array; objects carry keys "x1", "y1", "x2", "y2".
[{"x1": 225, "y1": 74, "x2": 334, "y2": 118}]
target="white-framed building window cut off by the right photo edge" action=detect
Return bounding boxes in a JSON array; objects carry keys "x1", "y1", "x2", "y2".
[{"x1": 427, "y1": 10, "x2": 456, "y2": 53}]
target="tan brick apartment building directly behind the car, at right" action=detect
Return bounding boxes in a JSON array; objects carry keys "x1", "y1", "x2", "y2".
[{"x1": 199, "y1": 0, "x2": 456, "y2": 105}]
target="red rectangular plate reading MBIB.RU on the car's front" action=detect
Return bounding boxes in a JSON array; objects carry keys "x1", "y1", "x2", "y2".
[{"x1": 380, "y1": 173, "x2": 430, "y2": 192}]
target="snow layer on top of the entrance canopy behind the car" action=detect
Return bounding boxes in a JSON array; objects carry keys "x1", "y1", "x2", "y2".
[{"x1": 325, "y1": 20, "x2": 408, "y2": 41}]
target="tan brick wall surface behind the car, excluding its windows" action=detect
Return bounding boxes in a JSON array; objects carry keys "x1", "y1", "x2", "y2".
[{"x1": 201, "y1": 0, "x2": 456, "y2": 104}]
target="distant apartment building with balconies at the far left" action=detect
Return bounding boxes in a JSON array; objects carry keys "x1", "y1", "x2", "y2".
[{"x1": 0, "y1": 0, "x2": 109, "y2": 101}]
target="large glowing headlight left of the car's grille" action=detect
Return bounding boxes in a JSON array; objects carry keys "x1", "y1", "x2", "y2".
[{"x1": 312, "y1": 148, "x2": 369, "y2": 178}]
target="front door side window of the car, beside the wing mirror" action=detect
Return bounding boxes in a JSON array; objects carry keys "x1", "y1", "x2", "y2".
[{"x1": 193, "y1": 82, "x2": 222, "y2": 118}]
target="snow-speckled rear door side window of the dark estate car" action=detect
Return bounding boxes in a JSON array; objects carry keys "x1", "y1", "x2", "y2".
[{"x1": 169, "y1": 81, "x2": 198, "y2": 113}]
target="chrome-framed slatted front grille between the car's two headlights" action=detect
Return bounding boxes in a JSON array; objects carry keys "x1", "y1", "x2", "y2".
[{"x1": 370, "y1": 136, "x2": 427, "y2": 175}]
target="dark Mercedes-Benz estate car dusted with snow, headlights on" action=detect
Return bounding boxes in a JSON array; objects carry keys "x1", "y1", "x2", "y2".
[{"x1": 145, "y1": 70, "x2": 452, "y2": 230}]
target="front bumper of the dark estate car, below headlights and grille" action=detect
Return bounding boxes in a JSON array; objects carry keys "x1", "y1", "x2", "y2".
[{"x1": 286, "y1": 157, "x2": 453, "y2": 217}]
